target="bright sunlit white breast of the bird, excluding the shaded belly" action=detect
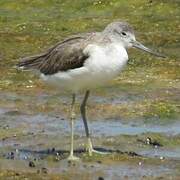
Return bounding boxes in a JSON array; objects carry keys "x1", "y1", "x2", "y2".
[{"x1": 84, "y1": 44, "x2": 128, "y2": 79}]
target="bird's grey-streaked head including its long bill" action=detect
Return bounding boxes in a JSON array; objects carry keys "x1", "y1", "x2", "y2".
[{"x1": 104, "y1": 22, "x2": 165, "y2": 58}]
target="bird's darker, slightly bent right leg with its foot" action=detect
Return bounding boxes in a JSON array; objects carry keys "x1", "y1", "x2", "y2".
[{"x1": 80, "y1": 90, "x2": 107, "y2": 156}]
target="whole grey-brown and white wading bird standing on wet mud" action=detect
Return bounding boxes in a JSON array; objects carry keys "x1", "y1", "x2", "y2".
[{"x1": 17, "y1": 21, "x2": 165, "y2": 161}]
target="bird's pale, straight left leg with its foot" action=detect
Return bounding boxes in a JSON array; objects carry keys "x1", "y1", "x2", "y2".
[{"x1": 68, "y1": 94, "x2": 79, "y2": 161}]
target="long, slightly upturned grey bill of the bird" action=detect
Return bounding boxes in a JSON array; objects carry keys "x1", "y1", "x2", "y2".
[{"x1": 132, "y1": 41, "x2": 166, "y2": 58}]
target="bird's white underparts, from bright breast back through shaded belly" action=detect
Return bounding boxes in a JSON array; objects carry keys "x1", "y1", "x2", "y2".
[{"x1": 41, "y1": 44, "x2": 128, "y2": 92}]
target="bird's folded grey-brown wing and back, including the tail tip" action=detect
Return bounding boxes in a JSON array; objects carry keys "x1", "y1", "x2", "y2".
[{"x1": 17, "y1": 33, "x2": 91, "y2": 75}]
